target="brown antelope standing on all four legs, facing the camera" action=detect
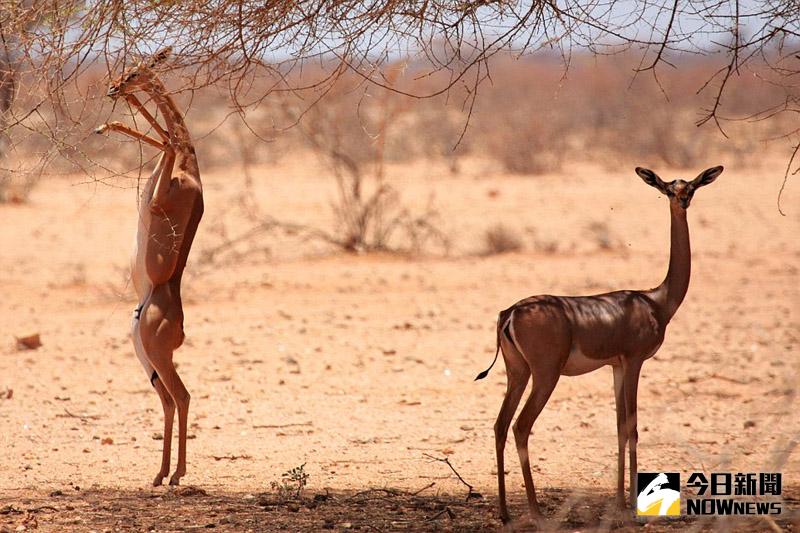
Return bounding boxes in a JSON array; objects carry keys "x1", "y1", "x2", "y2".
[{"x1": 475, "y1": 166, "x2": 722, "y2": 522}]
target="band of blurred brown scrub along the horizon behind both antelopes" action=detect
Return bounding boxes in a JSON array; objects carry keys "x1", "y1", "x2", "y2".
[{"x1": 10, "y1": 54, "x2": 797, "y2": 183}]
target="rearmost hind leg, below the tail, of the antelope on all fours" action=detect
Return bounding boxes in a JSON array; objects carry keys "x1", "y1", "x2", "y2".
[{"x1": 494, "y1": 345, "x2": 531, "y2": 523}]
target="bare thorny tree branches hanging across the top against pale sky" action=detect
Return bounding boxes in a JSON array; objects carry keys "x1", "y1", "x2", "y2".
[{"x1": 0, "y1": 0, "x2": 800, "y2": 195}]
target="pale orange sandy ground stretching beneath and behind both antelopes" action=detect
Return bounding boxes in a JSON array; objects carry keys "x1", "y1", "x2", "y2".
[{"x1": 0, "y1": 156, "x2": 800, "y2": 531}]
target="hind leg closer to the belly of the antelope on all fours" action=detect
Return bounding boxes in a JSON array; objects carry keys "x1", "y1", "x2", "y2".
[{"x1": 514, "y1": 371, "x2": 560, "y2": 519}]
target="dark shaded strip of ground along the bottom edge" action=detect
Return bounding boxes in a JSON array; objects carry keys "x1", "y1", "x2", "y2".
[{"x1": 0, "y1": 486, "x2": 800, "y2": 533}]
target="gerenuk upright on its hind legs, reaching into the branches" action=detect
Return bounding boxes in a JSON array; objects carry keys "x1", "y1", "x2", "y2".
[{"x1": 95, "y1": 49, "x2": 203, "y2": 485}]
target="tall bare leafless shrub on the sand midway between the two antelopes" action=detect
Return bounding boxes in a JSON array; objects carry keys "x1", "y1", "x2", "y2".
[{"x1": 270, "y1": 71, "x2": 449, "y2": 253}]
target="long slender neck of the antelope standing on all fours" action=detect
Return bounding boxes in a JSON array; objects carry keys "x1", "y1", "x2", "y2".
[{"x1": 653, "y1": 201, "x2": 692, "y2": 322}]
